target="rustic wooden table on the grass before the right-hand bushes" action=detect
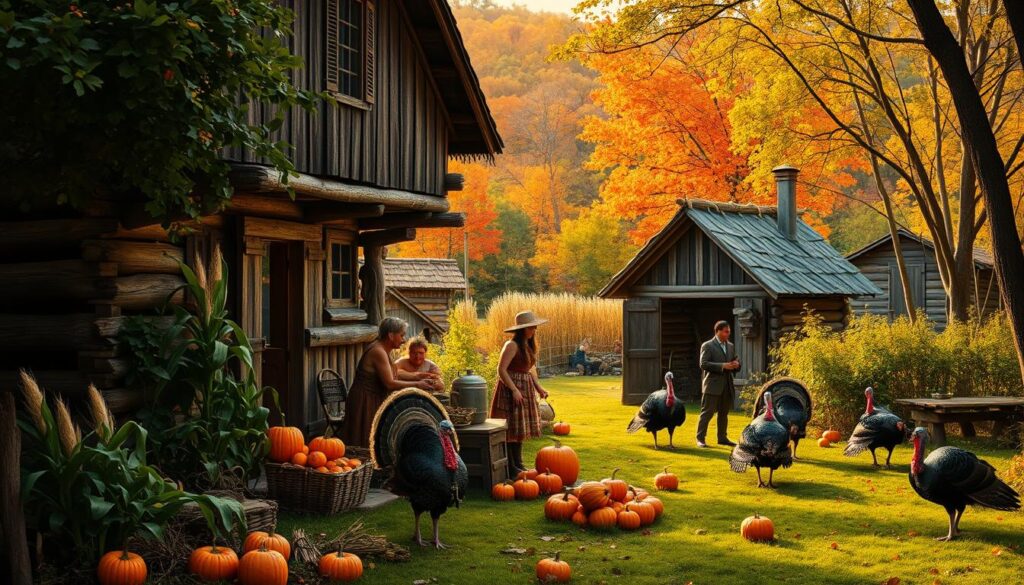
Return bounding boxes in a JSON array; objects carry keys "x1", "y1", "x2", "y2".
[{"x1": 896, "y1": 396, "x2": 1024, "y2": 446}]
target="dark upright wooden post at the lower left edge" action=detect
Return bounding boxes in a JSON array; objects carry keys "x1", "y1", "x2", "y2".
[{"x1": 0, "y1": 389, "x2": 32, "y2": 585}]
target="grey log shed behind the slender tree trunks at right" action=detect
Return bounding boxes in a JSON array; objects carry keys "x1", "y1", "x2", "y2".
[{"x1": 846, "y1": 227, "x2": 999, "y2": 331}]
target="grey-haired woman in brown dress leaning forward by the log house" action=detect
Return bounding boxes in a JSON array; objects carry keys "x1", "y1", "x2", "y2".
[{"x1": 341, "y1": 317, "x2": 432, "y2": 447}]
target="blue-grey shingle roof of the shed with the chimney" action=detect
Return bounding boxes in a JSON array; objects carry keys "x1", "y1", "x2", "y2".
[{"x1": 598, "y1": 200, "x2": 882, "y2": 297}]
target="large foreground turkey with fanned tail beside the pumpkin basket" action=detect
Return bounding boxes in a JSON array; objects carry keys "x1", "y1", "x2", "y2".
[{"x1": 370, "y1": 388, "x2": 469, "y2": 548}]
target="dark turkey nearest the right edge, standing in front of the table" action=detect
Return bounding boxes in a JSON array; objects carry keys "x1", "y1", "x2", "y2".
[{"x1": 910, "y1": 426, "x2": 1021, "y2": 540}]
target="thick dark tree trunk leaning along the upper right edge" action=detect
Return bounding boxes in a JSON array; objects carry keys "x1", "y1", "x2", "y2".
[{"x1": 907, "y1": 0, "x2": 1024, "y2": 377}]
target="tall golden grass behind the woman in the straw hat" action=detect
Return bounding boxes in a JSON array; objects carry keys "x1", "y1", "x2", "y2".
[{"x1": 479, "y1": 292, "x2": 623, "y2": 365}]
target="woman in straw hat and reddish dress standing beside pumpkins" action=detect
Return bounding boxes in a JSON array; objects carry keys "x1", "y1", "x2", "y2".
[{"x1": 490, "y1": 310, "x2": 548, "y2": 476}]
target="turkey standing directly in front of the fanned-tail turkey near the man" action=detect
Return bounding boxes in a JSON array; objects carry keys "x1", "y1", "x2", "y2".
[{"x1": 729, "y1": 391, "x2": 793, "y2": 488}]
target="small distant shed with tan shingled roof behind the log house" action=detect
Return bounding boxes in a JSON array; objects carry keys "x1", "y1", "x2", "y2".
[{"x1": 376, "y1": 258, "x2": 466, "y2": 343}]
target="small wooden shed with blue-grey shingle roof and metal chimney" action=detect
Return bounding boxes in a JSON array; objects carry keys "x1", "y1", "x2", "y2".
[{"x1": 598, "y1": 167, "x2": 881, "y2": 404}]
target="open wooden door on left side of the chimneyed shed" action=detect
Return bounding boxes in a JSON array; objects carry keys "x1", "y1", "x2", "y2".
[{"x1": 623, "y1": 297, "x2": 663, "y2": 405}]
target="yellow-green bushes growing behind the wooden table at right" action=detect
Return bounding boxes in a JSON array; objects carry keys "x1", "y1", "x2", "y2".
[{"x1": 770, "y1": 312, "x2": 1024, "y2": 431}]
